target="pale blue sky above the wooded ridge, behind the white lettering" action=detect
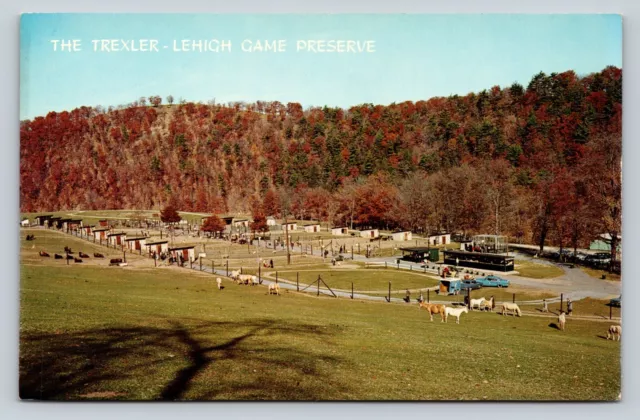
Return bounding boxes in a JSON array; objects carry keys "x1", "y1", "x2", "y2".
[{"x1": 20, "y1": 14, "x2": 622, "y2": 119}]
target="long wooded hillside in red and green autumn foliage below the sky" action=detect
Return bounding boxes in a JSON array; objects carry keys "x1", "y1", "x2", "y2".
[{"x1": 20, "y1": 67, "x2": 622, "y2": 251}]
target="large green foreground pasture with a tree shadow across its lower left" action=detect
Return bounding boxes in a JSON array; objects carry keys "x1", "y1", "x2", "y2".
[{"x1": 20, "y1": 233, "x2": 620, "y2": 400}]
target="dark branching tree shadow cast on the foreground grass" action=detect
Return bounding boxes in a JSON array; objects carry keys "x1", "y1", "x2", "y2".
[{"x1": 20, "y1": 320, "x2": 347, "y2": 400}]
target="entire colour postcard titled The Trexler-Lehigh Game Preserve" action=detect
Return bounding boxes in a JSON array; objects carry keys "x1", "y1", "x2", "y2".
[{"x1": 16, "y1": 14, "x2": 622, "y2": 401}]
